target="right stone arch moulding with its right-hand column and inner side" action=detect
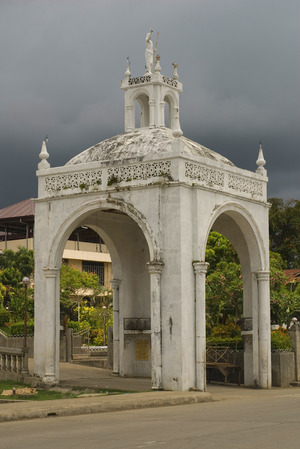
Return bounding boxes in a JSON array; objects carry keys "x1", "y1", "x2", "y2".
[{"x1": 201, "y1": 202, "x2": 271, "y2": 388}]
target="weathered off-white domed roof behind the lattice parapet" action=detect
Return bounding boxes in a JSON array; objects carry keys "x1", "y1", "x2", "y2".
[{"x1": 66, "y1": 128, "x2": 234, "y2": 166}]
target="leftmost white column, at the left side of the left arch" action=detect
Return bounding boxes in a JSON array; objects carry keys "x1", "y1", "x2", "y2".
[{"x1": 43, "y1": 268, "x2": 59, "y2": 384}]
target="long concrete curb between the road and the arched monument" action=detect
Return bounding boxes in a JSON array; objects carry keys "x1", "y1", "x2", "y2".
[{"x1": 0, "y1": 391, "x2": 212, "y2": 422}]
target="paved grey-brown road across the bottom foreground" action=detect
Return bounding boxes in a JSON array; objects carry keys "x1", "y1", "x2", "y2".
[{"x1": 0, "y1": 389, "x2": 300, "y2": 449}]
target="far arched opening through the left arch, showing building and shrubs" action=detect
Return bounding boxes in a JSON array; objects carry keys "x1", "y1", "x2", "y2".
[{"x1": 60, "y1": 225, "x2": 113, "y2": 346}]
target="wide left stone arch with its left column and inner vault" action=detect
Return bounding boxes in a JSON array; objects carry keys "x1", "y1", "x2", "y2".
[{"x1": 35, "y1": 198, "x2": 162, "y2": 385}]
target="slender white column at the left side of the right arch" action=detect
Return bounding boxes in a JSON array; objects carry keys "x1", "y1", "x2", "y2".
[{"x1": 193, "y1": 262, "x2": 209, "y2": 391}]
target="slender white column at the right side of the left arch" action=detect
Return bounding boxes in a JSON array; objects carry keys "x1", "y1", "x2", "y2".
[{"x1": 147, "y1": 260, "x2": 163, "y2": 390}]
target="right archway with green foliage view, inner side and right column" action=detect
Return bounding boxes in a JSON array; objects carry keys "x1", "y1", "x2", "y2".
[{"x1": 206, "y1": 205, "x2": 271, "y2": 387}]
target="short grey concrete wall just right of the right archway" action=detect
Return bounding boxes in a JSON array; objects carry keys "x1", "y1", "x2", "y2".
[{"x1": 272, "y1": 352, "x2": 295, "y2": 387}]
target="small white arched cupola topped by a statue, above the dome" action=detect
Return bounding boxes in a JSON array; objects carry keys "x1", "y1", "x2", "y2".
[{"x1": 121, "y1": 30, "x2": 183, "y2": 137}]
